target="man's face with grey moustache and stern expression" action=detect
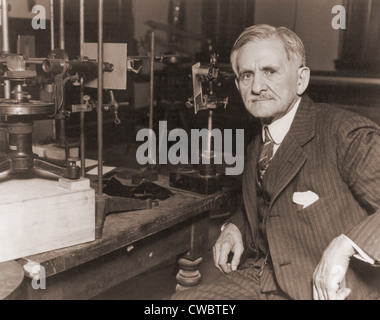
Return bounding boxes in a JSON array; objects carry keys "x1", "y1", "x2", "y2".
[{"x1": 236, "y1": 39, "x2": 299, "y2": 123}]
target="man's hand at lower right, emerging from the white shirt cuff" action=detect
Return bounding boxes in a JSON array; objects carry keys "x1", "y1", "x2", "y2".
[{"x1": 313, "y1": 235, "x2": 355, "y2": 300}]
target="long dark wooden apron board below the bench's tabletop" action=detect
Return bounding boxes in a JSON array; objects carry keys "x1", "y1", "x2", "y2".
[{"x1": 25, "y1": 222, "x2": 191, "y2": 300}]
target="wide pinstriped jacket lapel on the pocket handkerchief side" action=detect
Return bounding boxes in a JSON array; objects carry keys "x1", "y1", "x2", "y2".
[{"x1": 270, "y1": 98, "x2": 316, "y2": 207}]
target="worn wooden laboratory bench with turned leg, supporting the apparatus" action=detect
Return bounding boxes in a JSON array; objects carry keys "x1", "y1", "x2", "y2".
[{"x1": 13, "y1": 170, "x2": 234, "y2": 300}]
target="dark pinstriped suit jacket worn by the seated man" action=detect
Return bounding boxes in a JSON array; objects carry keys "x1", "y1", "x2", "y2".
[{"x1": 230, "y1": 97, "x2": 380, "y2": 299}]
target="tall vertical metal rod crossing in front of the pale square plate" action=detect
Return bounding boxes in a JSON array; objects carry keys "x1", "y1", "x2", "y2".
[{"x1": 97, "y1": 0, "x2": 103, "y2": 195}]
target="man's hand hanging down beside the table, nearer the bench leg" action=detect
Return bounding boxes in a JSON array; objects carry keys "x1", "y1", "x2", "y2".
[{"x1": 213, "y1": 223, "x2": 244, "y2": 273}]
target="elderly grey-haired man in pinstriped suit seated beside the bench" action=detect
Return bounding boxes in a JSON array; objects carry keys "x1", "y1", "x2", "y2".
[{"x1": 173, "y1": 25, "x2": 380, "y2": 300}]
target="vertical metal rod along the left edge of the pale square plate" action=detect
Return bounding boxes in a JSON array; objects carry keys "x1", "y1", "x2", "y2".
[{"x1": 79, "y1": 0, "x2": 86, "y2": 177}]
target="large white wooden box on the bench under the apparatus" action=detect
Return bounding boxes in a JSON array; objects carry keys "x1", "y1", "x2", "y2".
[{"x1": 0, "y1": 178, "x2": 95, "y2": 262}]
